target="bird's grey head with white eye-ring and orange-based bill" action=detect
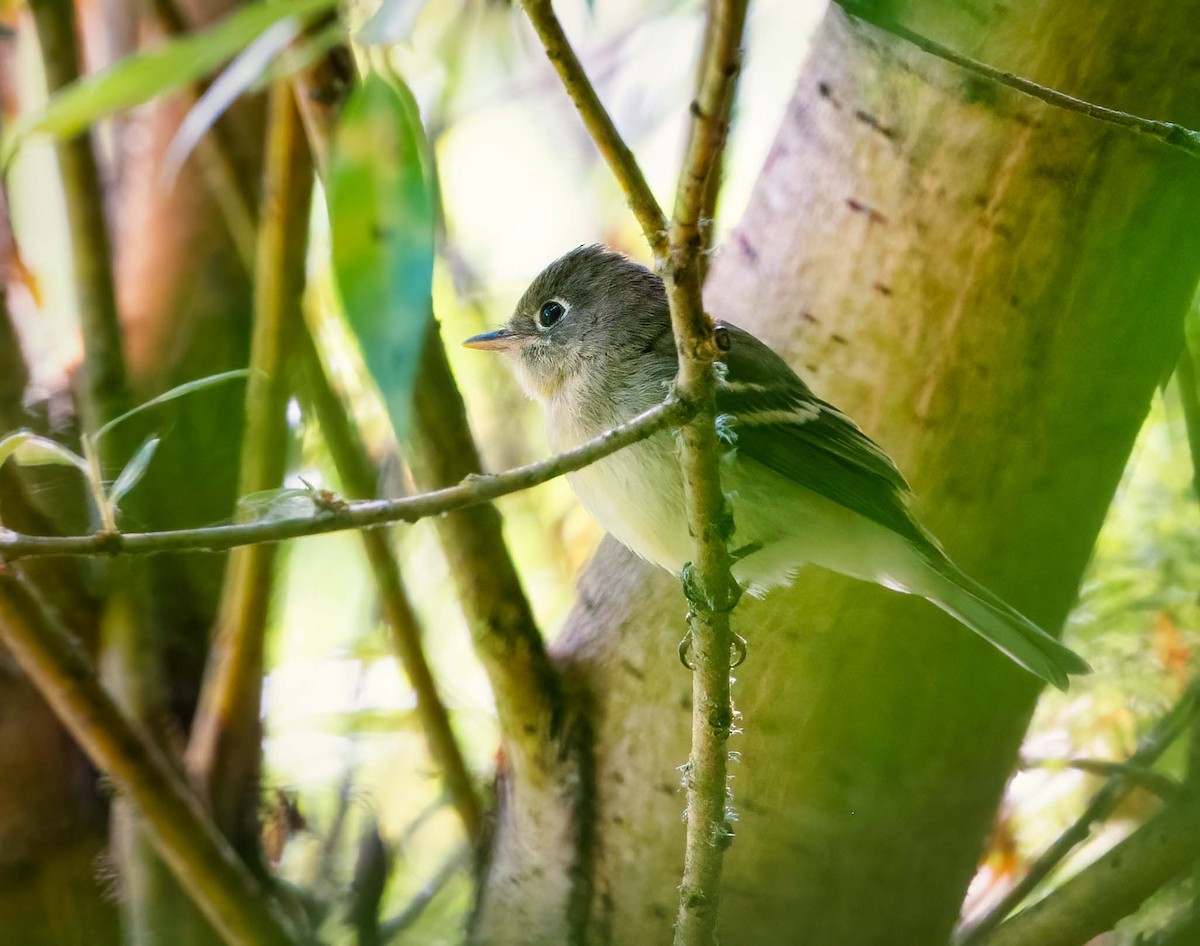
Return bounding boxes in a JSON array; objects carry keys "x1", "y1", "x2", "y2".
[{"x1": 463, "y1": 246, "x2": 673, "y2": 402}]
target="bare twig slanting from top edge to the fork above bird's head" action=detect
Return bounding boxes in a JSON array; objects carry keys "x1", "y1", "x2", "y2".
[{"x1": 521, "y1": 0, "x2": 667, "y2": 261}]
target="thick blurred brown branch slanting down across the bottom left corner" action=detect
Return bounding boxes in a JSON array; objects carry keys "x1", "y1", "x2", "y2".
[{"x1": 0, "y1": 568, "x2": 301, "y2": 946}]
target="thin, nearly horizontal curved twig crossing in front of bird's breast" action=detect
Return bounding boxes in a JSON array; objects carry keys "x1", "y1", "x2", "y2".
[{"x1": 0, "y1": 397, "x2": 695, "y2": 562}]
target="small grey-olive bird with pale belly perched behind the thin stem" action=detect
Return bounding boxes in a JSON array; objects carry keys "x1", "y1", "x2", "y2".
[{"x1": 463, "y1": 246, "x2": 1090, "y2": 689}]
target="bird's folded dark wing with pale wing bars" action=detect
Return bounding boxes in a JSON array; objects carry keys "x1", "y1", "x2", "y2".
[{"x1": 716, "y1": 322, "x2": 936, "y2": 550}]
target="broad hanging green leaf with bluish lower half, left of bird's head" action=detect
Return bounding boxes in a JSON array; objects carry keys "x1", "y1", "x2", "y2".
[{"x1": 329, "y1": 74, "x2": 433, "y2": 436}]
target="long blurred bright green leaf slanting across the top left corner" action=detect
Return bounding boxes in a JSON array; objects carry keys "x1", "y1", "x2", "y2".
[{"x1": 0, "y1": 0, "x2": 336, "y2": 164}]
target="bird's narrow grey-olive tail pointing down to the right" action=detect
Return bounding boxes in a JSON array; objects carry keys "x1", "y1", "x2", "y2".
[{"x1": 918, "y1": 549, "x2": 1092, "y2": 690}]
